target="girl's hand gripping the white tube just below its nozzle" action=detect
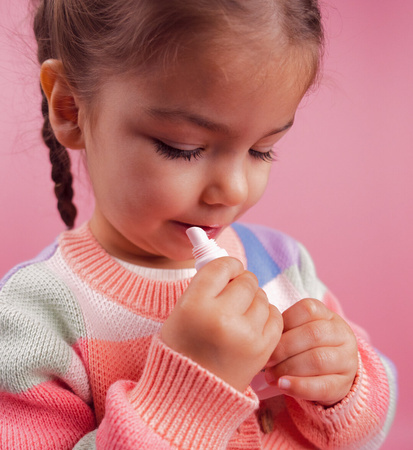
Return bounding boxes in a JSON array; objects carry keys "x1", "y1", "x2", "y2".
[{"x1": 161, "y1": 257, "x2": 283, "y2": 392}]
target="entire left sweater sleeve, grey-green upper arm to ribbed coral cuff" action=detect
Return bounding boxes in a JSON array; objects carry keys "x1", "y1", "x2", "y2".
[{"x1": 0, "y1": 267, "x2": 258, "y2": 450}]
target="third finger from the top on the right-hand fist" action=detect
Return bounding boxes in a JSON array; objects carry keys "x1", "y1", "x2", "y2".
[{"x1": 266, "y1": 347, "x2": 352, "y2": 382}]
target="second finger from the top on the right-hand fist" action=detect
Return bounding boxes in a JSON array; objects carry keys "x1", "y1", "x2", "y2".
[{"x1": 267, "y1": 320, "x2": 336, "y2": 367}]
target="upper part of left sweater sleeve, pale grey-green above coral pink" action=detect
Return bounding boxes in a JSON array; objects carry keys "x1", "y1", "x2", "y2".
[{"x1": 0, "y1": 264, "x2": 96, "y2": 450}]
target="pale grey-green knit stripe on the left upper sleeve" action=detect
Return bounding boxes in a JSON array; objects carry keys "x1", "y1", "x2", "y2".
[{"x1": 0, "y1": 264, "x2": 83, "y2": 392}]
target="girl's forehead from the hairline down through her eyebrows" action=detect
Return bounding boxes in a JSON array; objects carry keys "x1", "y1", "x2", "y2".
[{"x1": 100, "y1": 49, "x2": 304, "y2": 135}]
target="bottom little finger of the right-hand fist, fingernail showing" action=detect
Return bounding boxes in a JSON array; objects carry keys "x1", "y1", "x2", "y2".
[{"x1": 270, "y1": 374, "x2": 353, "y2": 406}]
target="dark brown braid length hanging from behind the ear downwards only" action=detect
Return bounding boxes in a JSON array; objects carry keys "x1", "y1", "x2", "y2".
[{"x1": 42, "y1": 87, "x2": 77, "y2": 229}]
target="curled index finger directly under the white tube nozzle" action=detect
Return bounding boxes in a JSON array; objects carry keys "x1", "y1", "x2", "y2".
[{"x1": 188, "y1": 257, "x2": 245, "y2": 297}]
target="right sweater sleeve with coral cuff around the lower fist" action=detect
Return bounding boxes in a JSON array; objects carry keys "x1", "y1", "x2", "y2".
[{"x1": 286, "y1": 246, "x2": 397, "y2": 449}]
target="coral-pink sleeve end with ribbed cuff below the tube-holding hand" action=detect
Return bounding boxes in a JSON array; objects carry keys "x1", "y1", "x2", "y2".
[{"x1": 97, "y1": 336, "x2": 258, "y2": 449}]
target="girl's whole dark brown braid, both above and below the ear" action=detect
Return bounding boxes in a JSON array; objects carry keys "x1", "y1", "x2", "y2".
[{"x1": 33, "y1": 0, "x2": 77, "y2": 229}]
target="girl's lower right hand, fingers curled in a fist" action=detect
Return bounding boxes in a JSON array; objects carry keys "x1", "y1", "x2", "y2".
[{"x1": 266, "y1": 298, "x2": 358, "y2": 406}]
